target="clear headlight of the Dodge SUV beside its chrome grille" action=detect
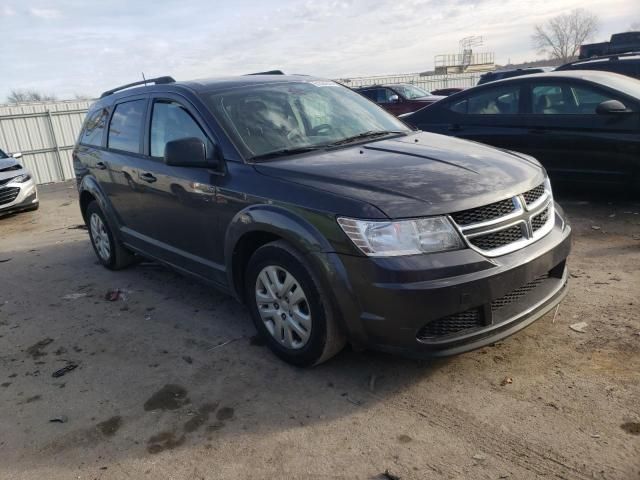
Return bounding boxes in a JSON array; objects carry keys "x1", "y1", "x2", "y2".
[{"x1": 338, "y1": 217, "x2": 464, "y2": 257}]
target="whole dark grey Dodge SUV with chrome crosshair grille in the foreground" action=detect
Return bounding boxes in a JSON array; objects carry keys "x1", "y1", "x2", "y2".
[{"x1": 73, "y1": 75, "x2": 570, "y2": 365}]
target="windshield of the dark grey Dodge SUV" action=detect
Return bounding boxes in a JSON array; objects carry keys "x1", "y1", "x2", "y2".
[{"x1": 203, "y1": 81, "x2": 410, "y2": 158}]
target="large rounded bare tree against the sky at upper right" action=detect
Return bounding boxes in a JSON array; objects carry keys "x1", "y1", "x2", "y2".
[{"x1": 532, "y1": 8, "x2": 599, "y2": 62}]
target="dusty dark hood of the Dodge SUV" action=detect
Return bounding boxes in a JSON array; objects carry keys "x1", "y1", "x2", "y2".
[{"x1": 255, "y1": 132, "x2": 545, "y2": 218}]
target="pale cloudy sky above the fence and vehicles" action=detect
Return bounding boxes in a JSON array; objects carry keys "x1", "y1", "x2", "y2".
[{"x1": 0, "y1": 0, "x2": 640, "y2": 101}]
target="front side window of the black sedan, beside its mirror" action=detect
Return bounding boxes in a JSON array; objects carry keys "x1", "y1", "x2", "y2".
[{"x1": 531, "y1": 84, "x2": 613, "y2": 115}]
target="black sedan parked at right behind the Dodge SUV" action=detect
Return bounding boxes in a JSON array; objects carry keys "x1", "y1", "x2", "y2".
[{"x1": 402, "y1": 70, "x2": 640, "y2": 189}]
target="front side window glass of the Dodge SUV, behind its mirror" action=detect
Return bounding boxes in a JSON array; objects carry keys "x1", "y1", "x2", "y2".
[{"x1": 149, "y1": 102, "x2": 213, "y2": 157}]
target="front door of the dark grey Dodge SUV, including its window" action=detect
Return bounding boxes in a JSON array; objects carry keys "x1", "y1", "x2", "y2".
[{"x1": 126, "y1": 94, "x2": 226, "y2": 283}]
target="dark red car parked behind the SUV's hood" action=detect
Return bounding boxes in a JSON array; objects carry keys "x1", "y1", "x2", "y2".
[{"x1": 354, "y1": 83, "x2": 445, "y2": 115}]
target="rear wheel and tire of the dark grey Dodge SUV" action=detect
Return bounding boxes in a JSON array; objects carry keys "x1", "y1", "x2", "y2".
[{"x1": 85, "y1": 200, "x2": 136, "y2": 270}]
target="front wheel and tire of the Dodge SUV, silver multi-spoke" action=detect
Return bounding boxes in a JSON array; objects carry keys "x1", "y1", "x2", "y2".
[{"x1": 245, "y1": 240, "x2": 346, "y2": 367}]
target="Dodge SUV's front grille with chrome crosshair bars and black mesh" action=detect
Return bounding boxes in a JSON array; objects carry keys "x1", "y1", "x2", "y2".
[{"x1": 450, "y1": 180, "x2": 554, "y2": 257}]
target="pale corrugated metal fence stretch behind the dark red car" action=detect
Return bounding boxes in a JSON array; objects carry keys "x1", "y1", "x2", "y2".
[{"x1": 336, "y1": 72, "x2": 481, "y2": 91}]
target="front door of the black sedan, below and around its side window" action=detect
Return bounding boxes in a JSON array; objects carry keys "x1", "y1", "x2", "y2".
[{"x1": 526, "y1": 79, "x2": 640, "y2": 184}]
